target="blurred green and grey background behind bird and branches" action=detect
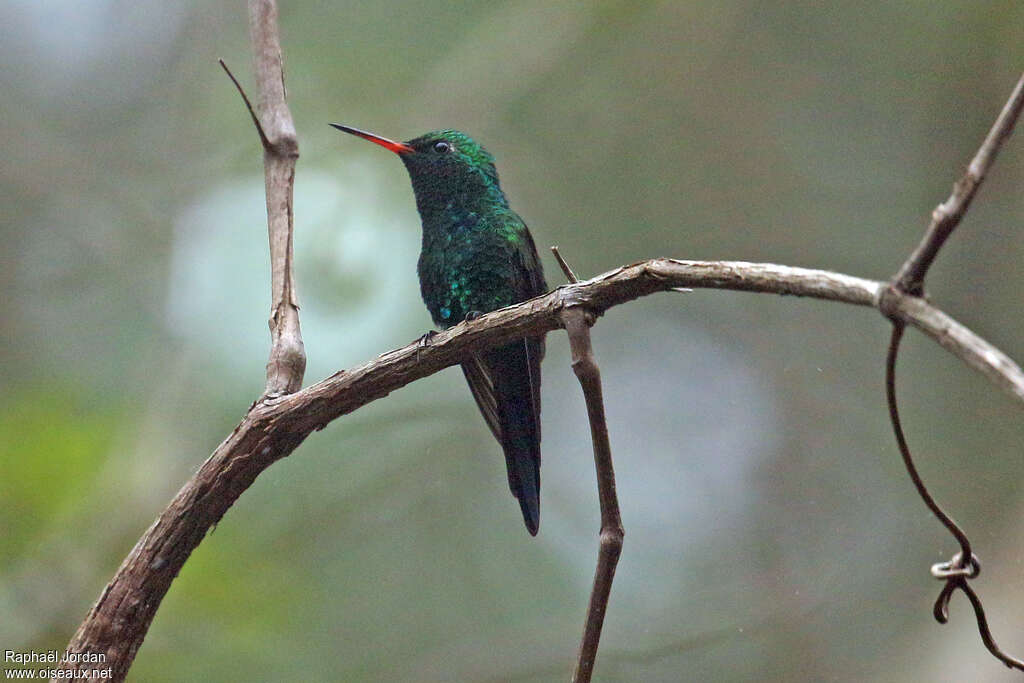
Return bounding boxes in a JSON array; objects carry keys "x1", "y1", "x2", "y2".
[{"x1": 0, "y1": 0, "x2": 1024, "y2": 682}]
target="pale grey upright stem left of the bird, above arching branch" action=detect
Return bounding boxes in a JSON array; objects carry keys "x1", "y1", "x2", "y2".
[{"x1": 246, "y1": 0, "x2": 306, "y2": 396}]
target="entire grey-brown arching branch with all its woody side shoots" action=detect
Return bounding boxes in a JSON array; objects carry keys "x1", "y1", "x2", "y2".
[{"x1": 54, "y1": 10, "x2": 1024, "y2": 681}]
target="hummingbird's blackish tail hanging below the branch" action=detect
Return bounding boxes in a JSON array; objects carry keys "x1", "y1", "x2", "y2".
[{"x1": 467, "y1": 339, "x2": 544, "y2": 536}]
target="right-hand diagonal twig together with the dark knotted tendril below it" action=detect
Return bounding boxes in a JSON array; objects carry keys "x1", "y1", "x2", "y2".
[{"x1": 879, "y1": 75, "x2": 1024, "y2": 671}]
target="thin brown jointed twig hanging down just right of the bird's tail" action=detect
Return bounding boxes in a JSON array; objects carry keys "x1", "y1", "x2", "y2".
[{"x1": 555, "y1": 309, "x2": 625, "y2": 683}]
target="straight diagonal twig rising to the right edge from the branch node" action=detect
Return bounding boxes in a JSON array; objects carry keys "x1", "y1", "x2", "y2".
[{"x1": 893, "y1": 75, "x2": 1024, "y2": 296}]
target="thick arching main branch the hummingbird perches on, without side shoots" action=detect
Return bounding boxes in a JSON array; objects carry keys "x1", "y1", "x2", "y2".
[{"x1": 54, "y1": 259, "x2": 1024, "y2": 681}]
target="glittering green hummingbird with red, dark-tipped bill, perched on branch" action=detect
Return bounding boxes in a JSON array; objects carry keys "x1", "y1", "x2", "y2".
[{"x1": 331, "y1": 124, "x2": 548, "y2": 536}]
